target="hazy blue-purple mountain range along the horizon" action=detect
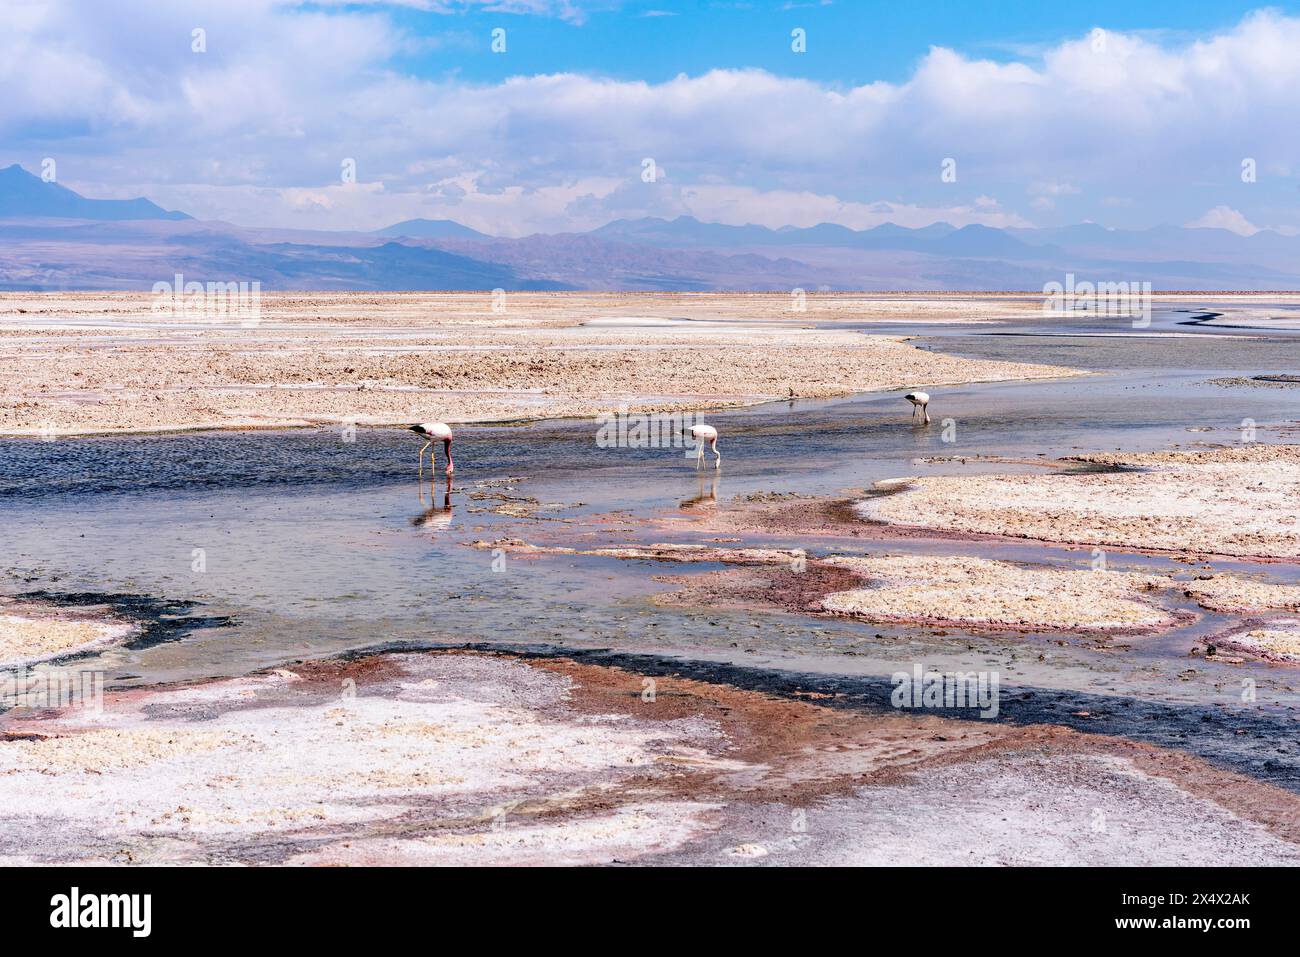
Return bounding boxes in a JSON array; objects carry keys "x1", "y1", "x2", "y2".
[{"x1": 0, "y1": 165, "x2": 1300, "y2": 291}]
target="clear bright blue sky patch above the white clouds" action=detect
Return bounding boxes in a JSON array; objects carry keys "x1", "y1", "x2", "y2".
[{"x1": 395, "y1": 0, "x2": 1296, "y2": 86}]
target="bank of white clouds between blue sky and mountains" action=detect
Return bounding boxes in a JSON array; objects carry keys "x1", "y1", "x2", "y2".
[{"x1": 0, "y1": 0, "x2": 1300, "y2": 233}]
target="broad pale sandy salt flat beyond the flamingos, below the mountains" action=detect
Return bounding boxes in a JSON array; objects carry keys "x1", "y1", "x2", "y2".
[{"x1": 0, "y1": 293, "x2": 1080, "y2": 438}]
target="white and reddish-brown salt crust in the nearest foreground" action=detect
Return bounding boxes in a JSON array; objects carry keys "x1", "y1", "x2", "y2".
[{"x1": 0, "y1": 653, "x2": 1300, "y2": 865}]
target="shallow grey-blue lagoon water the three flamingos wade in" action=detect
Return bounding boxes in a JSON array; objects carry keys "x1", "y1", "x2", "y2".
[{"x1": 0, "y1": 310, "x2": 1300, "y2": 785}]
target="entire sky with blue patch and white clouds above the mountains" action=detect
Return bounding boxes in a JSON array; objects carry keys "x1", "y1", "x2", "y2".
[{"x1": 0, "y1": 0, "x2": 1300, "y2": 235}]
